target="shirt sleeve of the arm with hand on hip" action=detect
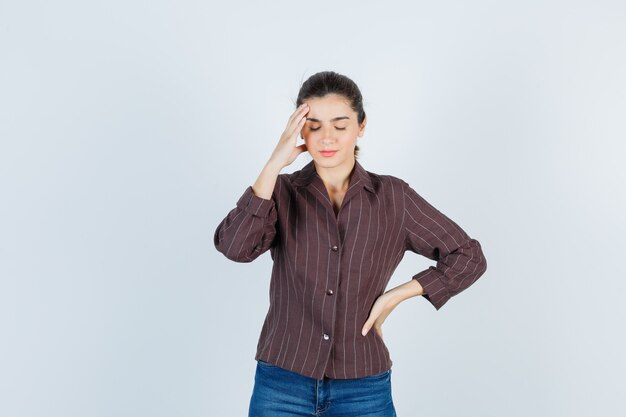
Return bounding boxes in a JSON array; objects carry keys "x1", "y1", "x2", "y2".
[{"x1": 404, "y1": 183, "x2": 487, "y2": 310}]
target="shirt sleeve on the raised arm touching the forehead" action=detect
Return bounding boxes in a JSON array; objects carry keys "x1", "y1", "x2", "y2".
[{"x1": 213, "y1": 186, "x2": 277, "y2": 262}]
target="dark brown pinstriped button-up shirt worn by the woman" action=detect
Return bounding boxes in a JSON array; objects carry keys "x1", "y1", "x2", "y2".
[{"x1": 214, "y1": 161, "x2": 487, "y2": 379}]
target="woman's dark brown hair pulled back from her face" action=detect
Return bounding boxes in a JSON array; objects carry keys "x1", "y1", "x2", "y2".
[{"x1": 296, "y1": 71, "x2": 365, "y2": 157}]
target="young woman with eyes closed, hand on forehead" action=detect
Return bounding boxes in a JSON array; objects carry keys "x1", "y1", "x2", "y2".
[{"x1": 214, "y1": 71, "x2": 487, "y2": 417}]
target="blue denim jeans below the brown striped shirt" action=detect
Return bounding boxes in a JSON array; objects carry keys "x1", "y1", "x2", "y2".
[{"x1": 248, "y1": 360, "x2": 396, "y2": 417}]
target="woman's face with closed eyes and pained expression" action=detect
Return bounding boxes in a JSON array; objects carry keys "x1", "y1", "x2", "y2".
[{"x1": 302, "y1": 94, "x2": 365, "y2": 168}]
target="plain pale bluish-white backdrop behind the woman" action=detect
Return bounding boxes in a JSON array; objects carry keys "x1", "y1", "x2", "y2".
[{"x1": 0, "y1": 0, "x2": 626, "y2": 417}]
